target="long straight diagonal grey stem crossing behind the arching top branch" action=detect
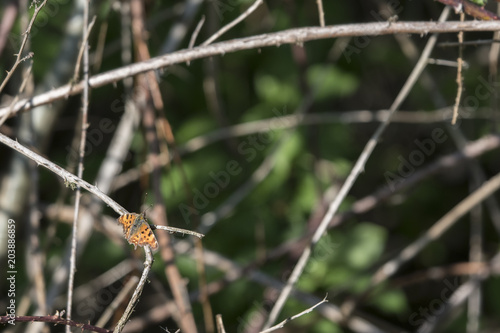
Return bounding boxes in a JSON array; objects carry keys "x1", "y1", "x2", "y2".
[{"x1": 264, "y1": 7, "x2": 450, "y2": 328}]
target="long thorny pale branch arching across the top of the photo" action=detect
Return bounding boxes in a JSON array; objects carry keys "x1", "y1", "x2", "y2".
[{"x1": 4, "y1": 21, "x2": 500, "y2": 116}]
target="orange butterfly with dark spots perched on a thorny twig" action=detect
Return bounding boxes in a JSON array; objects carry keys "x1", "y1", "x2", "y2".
[{"x1": 118, "y1": 213, "x2": 158, "y2": 250}]
